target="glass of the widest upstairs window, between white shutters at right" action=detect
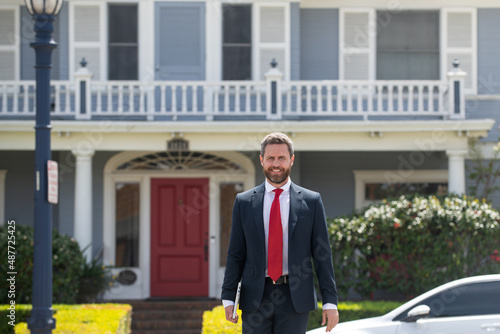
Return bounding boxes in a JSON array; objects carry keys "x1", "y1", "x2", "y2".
[{"x1": 377, "y1": 11, "x2": 439, "y2": 80}]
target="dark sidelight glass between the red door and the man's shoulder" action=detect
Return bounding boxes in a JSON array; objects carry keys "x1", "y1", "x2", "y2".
[{"x1": 220, "y1": 183, "x2": 243, "y2": 267}]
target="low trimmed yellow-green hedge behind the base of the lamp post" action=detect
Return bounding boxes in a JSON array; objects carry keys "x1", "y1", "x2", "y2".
[{"x1": 0, "y1": 304, "x2": 132, "y2": 334}]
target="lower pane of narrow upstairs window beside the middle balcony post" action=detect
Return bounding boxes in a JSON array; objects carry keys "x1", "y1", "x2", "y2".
[{"x1": 222, "y1": 47, "x2": 252, "y2": 80}]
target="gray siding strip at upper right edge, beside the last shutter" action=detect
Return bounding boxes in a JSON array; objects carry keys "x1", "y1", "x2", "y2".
[{"x1": 477, "y1": 8, "x2": 500, "y2": 94}]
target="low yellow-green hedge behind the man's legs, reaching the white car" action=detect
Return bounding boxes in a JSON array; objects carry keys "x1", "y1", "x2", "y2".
[{"x1": 202, "y1": 301, "x2": 401, "y2": 334}]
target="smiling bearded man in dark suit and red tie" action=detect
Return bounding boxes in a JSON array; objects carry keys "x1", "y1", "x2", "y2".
[{"x1": 222, "y1": 132, "x2": 339, "y2": 334}]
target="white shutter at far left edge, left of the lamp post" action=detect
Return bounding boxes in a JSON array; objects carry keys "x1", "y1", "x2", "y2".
[{"x1": 0, "y1": 8, "x2": 19, "y2": 80}]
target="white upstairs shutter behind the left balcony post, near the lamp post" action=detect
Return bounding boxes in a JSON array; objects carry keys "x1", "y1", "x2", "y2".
[{"x1": 71, "y1": 4, "x2": 104, "y2": 80}]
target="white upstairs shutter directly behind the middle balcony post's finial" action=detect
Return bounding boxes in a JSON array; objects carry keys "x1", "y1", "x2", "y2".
[{"x1": 254, "y1": 4, "x2": 289, "y2": 80}]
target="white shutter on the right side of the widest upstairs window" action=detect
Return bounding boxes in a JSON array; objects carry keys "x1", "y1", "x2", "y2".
[{"x1": 441, "y1": 9, "x2": 477, "y2": 93}]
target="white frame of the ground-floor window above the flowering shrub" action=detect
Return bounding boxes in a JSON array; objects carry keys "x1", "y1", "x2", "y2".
[{"x1": 353, "y1": 169, "x2": 448, "y2": 210}]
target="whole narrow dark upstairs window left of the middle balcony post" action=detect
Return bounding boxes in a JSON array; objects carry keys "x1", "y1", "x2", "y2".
[{"x1": 222, "y1": 5, "x2": 252, "y2": 80}]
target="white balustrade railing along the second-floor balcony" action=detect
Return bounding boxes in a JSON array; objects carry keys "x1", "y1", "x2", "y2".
[{"x1": 0, "y1": 65, "x2": 465, "y2": 121}]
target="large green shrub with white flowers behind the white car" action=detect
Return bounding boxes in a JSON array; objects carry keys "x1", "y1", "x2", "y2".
[{"x1": 329, "y1": 195, "x2": 500, "y2": 297}]
